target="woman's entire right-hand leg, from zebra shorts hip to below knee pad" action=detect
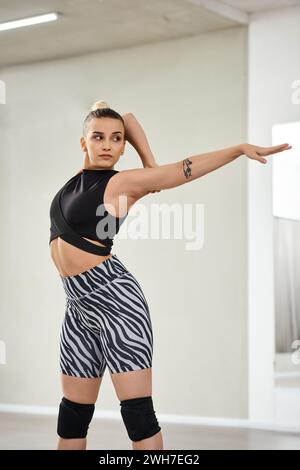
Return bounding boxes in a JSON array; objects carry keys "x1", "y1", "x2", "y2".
[{"x1": 98, "y1": 261, "x2": 163, "y2": 449}]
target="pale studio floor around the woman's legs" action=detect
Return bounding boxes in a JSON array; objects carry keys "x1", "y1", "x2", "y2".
[{"x1": 0, "y1": 412, "x2": 300, "y2": 450}]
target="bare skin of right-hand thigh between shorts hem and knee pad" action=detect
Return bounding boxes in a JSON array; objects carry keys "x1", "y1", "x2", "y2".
[{"x1": 110, "y1": 367, "x2": 152, "y2": 401}]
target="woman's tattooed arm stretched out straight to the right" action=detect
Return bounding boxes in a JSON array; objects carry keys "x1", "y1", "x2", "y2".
[{"x1": 116, "y1": 144, "x2": 291, "y2": 200}]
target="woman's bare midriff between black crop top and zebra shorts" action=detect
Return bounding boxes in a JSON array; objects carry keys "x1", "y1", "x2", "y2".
[{"x1": 50, "y1": 237, "x2": 112, "y2": 277}]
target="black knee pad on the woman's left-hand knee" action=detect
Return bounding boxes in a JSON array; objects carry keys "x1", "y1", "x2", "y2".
[{"x1": 57, "y1": 397, "x2": 95, "y2": 439}]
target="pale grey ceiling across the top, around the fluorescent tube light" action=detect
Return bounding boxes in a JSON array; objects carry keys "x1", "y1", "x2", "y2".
[{"x1": 0, "y1": 0, "x2": 300, "y2": 68}]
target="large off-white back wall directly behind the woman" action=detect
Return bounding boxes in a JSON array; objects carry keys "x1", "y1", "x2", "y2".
[{"x1": 0, "y1": 28, "x2": 248, "y2": 418}]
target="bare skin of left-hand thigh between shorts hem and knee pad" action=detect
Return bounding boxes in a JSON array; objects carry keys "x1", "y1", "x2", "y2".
[{"x1": 61, "y1": 374, "x2": 102, "y2": 404}]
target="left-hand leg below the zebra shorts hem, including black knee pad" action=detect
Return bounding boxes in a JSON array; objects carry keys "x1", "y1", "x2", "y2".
[{"x1": 57, "y1": 374, "x2": 102, "y2": 450}]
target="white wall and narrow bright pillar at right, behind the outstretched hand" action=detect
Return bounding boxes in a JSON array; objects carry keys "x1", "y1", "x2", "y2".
[{"x1": 248, "y1": 3, "x2": 300, "y2": 421}]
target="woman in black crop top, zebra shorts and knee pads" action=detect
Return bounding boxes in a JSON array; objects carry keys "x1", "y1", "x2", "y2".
[{"x1": 50, "y1": 102, "x2": 291, "y2": 450}]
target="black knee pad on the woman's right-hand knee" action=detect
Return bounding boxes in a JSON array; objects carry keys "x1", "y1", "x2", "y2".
[{"x1": 120, "y1": 397, "x2": 161, "y2": 441}]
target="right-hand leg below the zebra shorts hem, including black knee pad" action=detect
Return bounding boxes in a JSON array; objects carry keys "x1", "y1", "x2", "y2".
[{"x1": 110, "y1": 367, "x2": 163, "y2": 450}]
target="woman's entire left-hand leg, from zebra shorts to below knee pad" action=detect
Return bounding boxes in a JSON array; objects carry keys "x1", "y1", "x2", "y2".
[{"x1": 57, "y1": 304, "x2": 106, "y2": 450}]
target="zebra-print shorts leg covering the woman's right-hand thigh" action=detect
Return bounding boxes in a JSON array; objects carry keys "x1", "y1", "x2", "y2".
[{"x1": 98, "y1": 272, "x2": 153, "y2": 374}]
